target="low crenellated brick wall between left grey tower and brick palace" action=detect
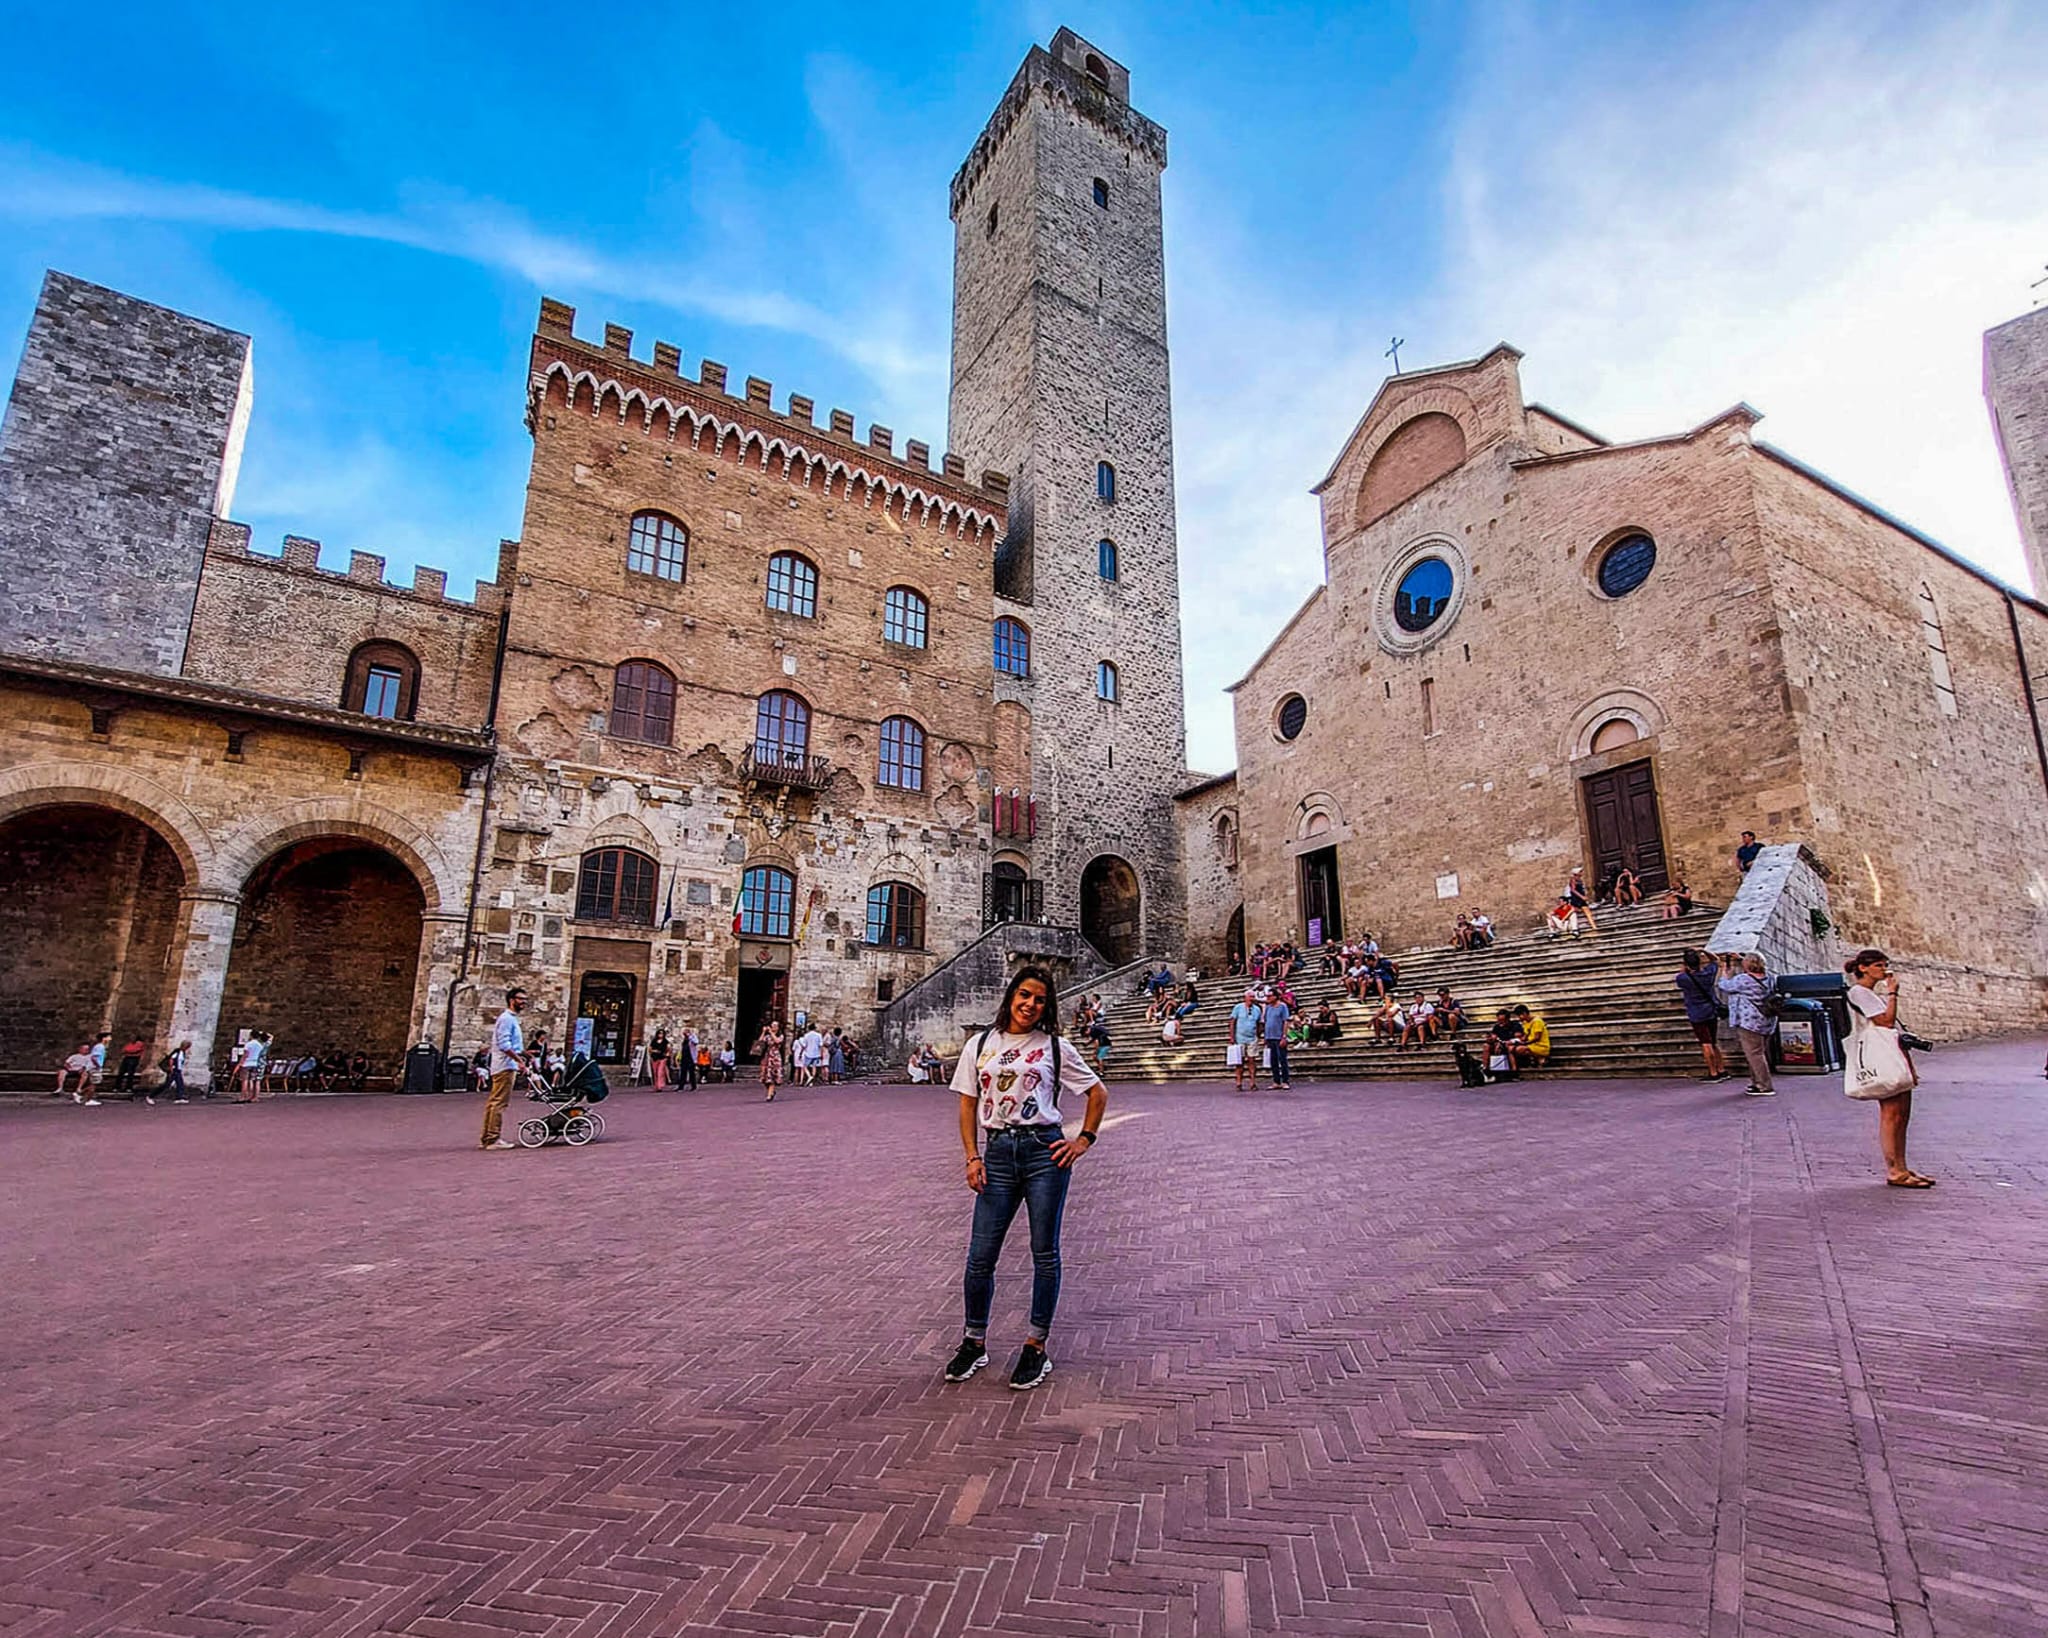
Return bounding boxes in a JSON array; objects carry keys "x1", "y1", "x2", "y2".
[{"x1": 184, "y1": 522, "x2": 516, "y2": 729}]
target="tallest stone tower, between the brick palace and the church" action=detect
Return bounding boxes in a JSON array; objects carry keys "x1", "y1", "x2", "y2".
[{"x1": 950, "y1": 29, "x2": 1188, "y2": 960}]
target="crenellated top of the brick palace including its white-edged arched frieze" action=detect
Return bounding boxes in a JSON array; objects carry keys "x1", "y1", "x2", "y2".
[{"x1": 526, "y1": 297, "x2": 1010, "y2": 534}]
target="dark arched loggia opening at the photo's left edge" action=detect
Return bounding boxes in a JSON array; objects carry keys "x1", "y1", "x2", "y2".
[{"x1": 0, "y1": 805, "x2": 186, "y2": 1083}]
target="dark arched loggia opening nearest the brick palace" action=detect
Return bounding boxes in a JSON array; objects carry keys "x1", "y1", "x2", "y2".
[{"x1": 219, "y1": 835, "x2": 426, "y2": 1075}]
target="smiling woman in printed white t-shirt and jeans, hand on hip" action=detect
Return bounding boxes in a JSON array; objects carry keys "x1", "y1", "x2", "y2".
[{"x1": 946, "y1": 966, "x2": 1110, "y2": 1388}]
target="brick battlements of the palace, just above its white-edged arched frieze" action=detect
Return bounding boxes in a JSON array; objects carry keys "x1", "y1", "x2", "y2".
[{"x1": 535, "y1": 297, "x2": 1010, "y2": 505}]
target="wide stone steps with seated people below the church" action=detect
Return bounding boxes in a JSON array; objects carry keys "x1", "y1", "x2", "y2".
[{"x1": 1090, "y1": 905, "x2": 1720, "y2": 1083}]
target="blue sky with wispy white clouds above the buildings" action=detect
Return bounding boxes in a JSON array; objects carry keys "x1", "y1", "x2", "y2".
[{"x1": 0, "y1": 0, "x2": 2048, "y2": 768}]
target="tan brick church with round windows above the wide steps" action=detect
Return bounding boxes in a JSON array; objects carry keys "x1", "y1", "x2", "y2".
[{"x1": 1182, "y1": 346, "x2": 2048, "y2": 1032}]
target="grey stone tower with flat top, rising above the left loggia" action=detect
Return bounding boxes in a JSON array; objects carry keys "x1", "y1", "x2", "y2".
[{"x1": 0, "y1": 272, "x2": 250, "y2": 676}]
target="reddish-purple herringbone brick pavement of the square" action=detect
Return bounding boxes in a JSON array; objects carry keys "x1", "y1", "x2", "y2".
[{"x1": 0, "y1": 1044, "x2": 2048, "y2": 1638}]
